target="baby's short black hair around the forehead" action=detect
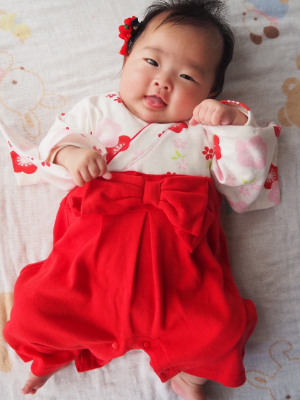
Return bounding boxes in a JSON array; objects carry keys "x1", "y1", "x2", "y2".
[{"x1": 127, "y1": 0, "x2": 234, "y2": 97}]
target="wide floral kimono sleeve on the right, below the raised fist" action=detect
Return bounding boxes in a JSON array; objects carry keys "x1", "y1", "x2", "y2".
[{"x1": 205, "y1": 104, "x2": 280, "y2": 213}]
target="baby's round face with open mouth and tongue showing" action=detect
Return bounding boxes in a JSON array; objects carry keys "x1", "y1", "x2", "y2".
[{"x1": 120, "y1": 19, "x2": 222, "y2": 123}]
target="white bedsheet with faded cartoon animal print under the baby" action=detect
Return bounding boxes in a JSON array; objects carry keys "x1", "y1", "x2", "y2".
[{"x1": 0, "y1": 0, "x2": 300, "y2": 400}]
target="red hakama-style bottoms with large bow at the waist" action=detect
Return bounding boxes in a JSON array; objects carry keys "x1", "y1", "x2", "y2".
[{"x1": 4, "y1": 172, "x2": 256, "y2": 387}]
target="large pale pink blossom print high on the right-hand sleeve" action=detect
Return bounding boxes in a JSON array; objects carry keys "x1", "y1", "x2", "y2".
[{"x1": 235, "y1": 136, "x2": 267, "y2": 169}]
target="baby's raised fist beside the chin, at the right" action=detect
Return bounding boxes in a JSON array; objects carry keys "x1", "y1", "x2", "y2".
[{"x1": 189, "y1": 99, "x2": 248, "y2": 126}]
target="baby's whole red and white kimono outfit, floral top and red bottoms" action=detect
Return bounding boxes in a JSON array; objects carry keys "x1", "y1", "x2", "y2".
[{"x1": 2, "y1": 93, "x2": 280, "y2": 386}]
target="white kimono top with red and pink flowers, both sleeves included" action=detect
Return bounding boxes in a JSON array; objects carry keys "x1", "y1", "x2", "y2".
[{"x1": 0, "y1": 92, "x2": 280, "y2": 212}]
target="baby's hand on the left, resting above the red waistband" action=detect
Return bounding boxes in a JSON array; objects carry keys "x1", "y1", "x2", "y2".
[{"x1": 54, "y1": 146, "x2": 112, "y2": 186}]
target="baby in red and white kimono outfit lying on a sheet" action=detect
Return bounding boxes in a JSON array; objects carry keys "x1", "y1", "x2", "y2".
[{"x1": 4, "y1": 0, "x2": 279, "y2": 400}]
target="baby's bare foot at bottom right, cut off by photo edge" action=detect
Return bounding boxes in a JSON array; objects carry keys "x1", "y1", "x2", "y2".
[{"x1": 171, "y1": 371, "x2": 207, "y2": 400}]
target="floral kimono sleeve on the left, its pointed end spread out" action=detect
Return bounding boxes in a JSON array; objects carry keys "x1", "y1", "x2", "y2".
[{"x1": 0, "y1": 96, "x2": 106, "y2": 191}]
